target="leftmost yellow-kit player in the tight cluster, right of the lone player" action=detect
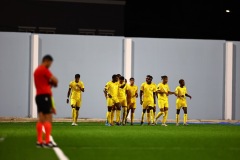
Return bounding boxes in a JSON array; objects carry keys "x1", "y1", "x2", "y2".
[{"x1": 105, "y1": 74, "x2": 121, "y2": 126}]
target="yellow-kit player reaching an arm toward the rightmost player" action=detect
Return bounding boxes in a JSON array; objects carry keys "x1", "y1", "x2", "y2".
[{"x1": 155, "y1": 76, "x2": 175, "y2": 126}]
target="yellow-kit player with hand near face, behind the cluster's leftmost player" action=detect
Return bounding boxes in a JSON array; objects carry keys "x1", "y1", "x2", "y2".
[{"x1": 117, "y1": 76, "x2": 127, "y2": 125}]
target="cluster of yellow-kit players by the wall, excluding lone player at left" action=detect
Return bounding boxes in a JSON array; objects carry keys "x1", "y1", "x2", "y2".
[{"x1": 104, "y1": 74, "x2": 192, "y2": 126}]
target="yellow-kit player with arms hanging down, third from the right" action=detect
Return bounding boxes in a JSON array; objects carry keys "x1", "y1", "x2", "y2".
[{"x1": 140, "y1": 75, "x2": 156, "y2": 125}]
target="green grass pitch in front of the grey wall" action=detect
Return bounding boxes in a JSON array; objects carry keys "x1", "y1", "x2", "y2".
[{"x1": 0, "y1": 122, "x2": 240, "y2": 160}]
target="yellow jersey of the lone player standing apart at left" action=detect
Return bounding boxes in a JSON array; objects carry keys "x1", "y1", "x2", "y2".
[{"x1": 69, "y1": 80, "x2": 84, "y2": 100}]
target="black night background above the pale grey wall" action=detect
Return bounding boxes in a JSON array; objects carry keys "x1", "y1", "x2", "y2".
[{"x1": 0, "y1": 0, "x2": 240, "y2": 40}]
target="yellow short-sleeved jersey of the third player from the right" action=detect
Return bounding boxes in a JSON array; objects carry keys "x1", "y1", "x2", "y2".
[{"x1": 141, "y1": 82, "x2": 156, "y2": 101}]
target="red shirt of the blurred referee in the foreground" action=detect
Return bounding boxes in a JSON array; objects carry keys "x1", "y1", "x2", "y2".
[{"x1": 34, "y1": 65, "x2": 52, "y2": 95}]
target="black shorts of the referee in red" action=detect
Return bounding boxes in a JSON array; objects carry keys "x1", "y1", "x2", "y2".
[{"x1": 35, "y1": 94, "x2": 52, "y2": 114}]
